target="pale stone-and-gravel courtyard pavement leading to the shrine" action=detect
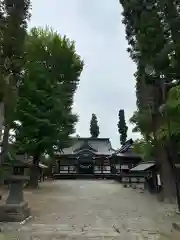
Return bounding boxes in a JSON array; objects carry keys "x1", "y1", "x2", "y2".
[{"x1": 0, "y1": 180, "x2": 180, "y2": 240}]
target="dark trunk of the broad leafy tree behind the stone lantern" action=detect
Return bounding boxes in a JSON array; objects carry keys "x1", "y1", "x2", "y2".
[{"x1": 28, "y1": 152, "x2": 40, "y2": 188}]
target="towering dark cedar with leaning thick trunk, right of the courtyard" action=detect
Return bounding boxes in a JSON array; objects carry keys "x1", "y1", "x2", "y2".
[{"x1": 120, "y1": 0, "x2": 180, "y2": 200}]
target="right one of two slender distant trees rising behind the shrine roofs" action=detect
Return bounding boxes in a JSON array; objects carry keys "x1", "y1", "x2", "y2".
[{"x1": 117, "y1": 109, "x2": 128, "y2": 145}]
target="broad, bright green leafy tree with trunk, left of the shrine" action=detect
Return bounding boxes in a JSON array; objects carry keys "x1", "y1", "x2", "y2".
[{"x1": 15, "y1": 28, "x2": 83, "y2": 187}]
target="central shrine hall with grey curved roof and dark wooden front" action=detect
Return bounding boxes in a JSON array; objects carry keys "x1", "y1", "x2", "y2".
[{"x1": 54, "y1": 138, "x2": 114, "y2": 178}]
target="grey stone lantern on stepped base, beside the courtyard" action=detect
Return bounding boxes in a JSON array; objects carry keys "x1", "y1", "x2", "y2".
[{"x1": 0, "y1": 153, "x2": 30, "y2": 222}]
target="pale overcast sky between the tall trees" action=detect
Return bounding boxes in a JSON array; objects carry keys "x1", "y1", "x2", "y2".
[{"x1": 30, "y1": 0, "x2": 138, "y2": 148}]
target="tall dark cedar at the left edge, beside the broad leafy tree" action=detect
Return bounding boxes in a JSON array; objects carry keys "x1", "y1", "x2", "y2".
[{"x1": 0, "y1": 0, "x2": 30, "y2": 163}]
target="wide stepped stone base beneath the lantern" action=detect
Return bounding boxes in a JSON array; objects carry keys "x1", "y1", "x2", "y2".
[{"x1": 0, "y1": 202, "x2": 30, "y2": 222}]
